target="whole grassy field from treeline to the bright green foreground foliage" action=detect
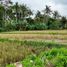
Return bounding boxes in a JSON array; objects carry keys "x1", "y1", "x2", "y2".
[{"x1": 0, "y1": 30, "x2": 67, "y2": 67}]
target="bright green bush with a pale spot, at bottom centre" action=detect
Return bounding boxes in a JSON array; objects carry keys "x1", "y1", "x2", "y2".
[{"x1": 22, "y1": 55, "x2": 44, "y2": 67}]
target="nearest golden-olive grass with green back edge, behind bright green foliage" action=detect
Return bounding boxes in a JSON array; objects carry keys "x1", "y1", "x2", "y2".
[{"x1": 0, "y1": 39, "x2": 67, "y2": 66}]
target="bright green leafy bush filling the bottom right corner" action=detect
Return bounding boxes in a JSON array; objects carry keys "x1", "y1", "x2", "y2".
[{"x1": 44, "y1": 48, "x2": 67, "y2": 67}]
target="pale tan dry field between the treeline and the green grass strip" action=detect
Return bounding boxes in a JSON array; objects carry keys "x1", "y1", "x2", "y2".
[{"x1": 0, "y1": 30, "x2": 67, "y2": 43}]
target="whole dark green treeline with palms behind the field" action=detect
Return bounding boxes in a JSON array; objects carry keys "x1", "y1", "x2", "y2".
[{"x1": 0, "y1": 0, "x2": 67, "y2": 31}]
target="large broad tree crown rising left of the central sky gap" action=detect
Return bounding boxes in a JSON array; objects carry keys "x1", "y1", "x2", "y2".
[{"x1": 12, "y1": 2, "x2": 33, "y2": 22}]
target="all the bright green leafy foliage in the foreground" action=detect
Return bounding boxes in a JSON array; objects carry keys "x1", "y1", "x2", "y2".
[{"x1": 6, "y1": 48, "x2": 67, "y2": 67}]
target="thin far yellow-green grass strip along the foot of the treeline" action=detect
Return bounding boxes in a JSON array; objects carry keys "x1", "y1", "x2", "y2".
[{"x1": 1, "y1": 30, "x2": 67, "y2": 35}]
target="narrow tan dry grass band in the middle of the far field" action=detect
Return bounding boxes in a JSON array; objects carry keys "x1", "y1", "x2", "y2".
[{"x1": 0, "y1": 34, "x2": 67, "y2": 40}]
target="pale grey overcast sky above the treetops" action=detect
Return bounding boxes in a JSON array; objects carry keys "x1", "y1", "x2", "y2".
[{"x1": 12, "y1": 0, "x2": 67, "y2": 16}]
